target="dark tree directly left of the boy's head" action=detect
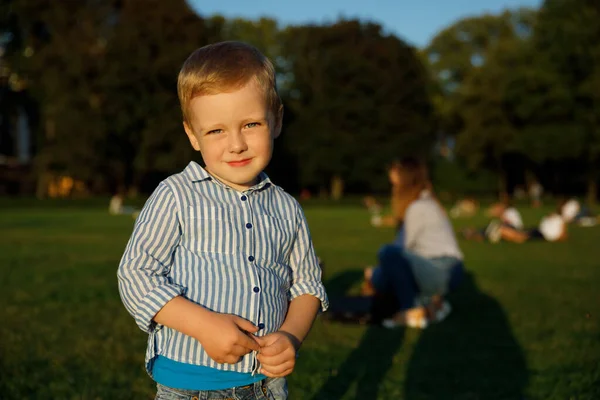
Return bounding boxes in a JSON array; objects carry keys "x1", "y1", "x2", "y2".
[{"x1": 102, "y1": 0, "x2": 221, "y2": 194}]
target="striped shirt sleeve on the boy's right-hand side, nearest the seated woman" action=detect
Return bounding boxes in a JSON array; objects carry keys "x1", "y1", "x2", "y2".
[{"x1": 289, "y1": 205, "x2": 329, "y2": 311}]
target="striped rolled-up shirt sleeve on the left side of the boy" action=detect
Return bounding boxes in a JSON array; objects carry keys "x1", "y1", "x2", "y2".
[{"x1": 117, "y1": 183, "x2": 185, "y2": 332}]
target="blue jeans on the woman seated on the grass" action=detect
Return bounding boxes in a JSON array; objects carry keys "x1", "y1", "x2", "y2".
[{"x1": 371, "y1": 245, "x2": 464, "y2": 311}]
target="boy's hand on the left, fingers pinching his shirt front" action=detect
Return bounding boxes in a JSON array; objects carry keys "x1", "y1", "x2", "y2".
[{"x1": 197, "y1": 313, "x2": 260, "y2": 364}]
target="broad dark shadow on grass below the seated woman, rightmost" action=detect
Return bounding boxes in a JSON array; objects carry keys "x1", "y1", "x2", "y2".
[{"x1": 404, "y1": 273, "x2": 528, "y2": 400}]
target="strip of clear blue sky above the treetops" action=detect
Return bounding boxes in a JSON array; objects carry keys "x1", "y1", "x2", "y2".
[{"x1": 187, "y1": 0, "x2": 542, "y2": 47}]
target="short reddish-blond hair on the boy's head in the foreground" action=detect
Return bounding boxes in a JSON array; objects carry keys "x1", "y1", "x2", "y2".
[{"x1": 177, "y1": 41, "x2": 282, "y2": 124}]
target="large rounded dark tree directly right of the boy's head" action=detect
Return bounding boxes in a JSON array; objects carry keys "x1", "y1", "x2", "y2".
[{"x1": 281, "y1": 21, "x2": 433, "y2": 195}]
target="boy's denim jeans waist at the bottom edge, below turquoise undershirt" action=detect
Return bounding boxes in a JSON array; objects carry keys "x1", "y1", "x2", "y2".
[{"x1": 154, "y1": 378, "x2": 287, "y2": 400}]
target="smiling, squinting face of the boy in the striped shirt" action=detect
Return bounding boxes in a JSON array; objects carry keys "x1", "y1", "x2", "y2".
[{"x1": 184, "y1": 79, "x2": 281, "y2": 191}]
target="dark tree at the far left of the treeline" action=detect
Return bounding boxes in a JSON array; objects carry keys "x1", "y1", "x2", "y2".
[{"x1": 8, "y1": 0, "x2": 121, "y2": 194}]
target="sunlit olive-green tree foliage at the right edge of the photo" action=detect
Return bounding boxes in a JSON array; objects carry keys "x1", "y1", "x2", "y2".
[{"x1": 425, "y1": 4, "x2": 600, "y2": 200}]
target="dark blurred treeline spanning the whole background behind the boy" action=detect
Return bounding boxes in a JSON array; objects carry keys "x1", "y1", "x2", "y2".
[{"x1": 0, "y1": 0, "x2": 600, "y2": 202}]
